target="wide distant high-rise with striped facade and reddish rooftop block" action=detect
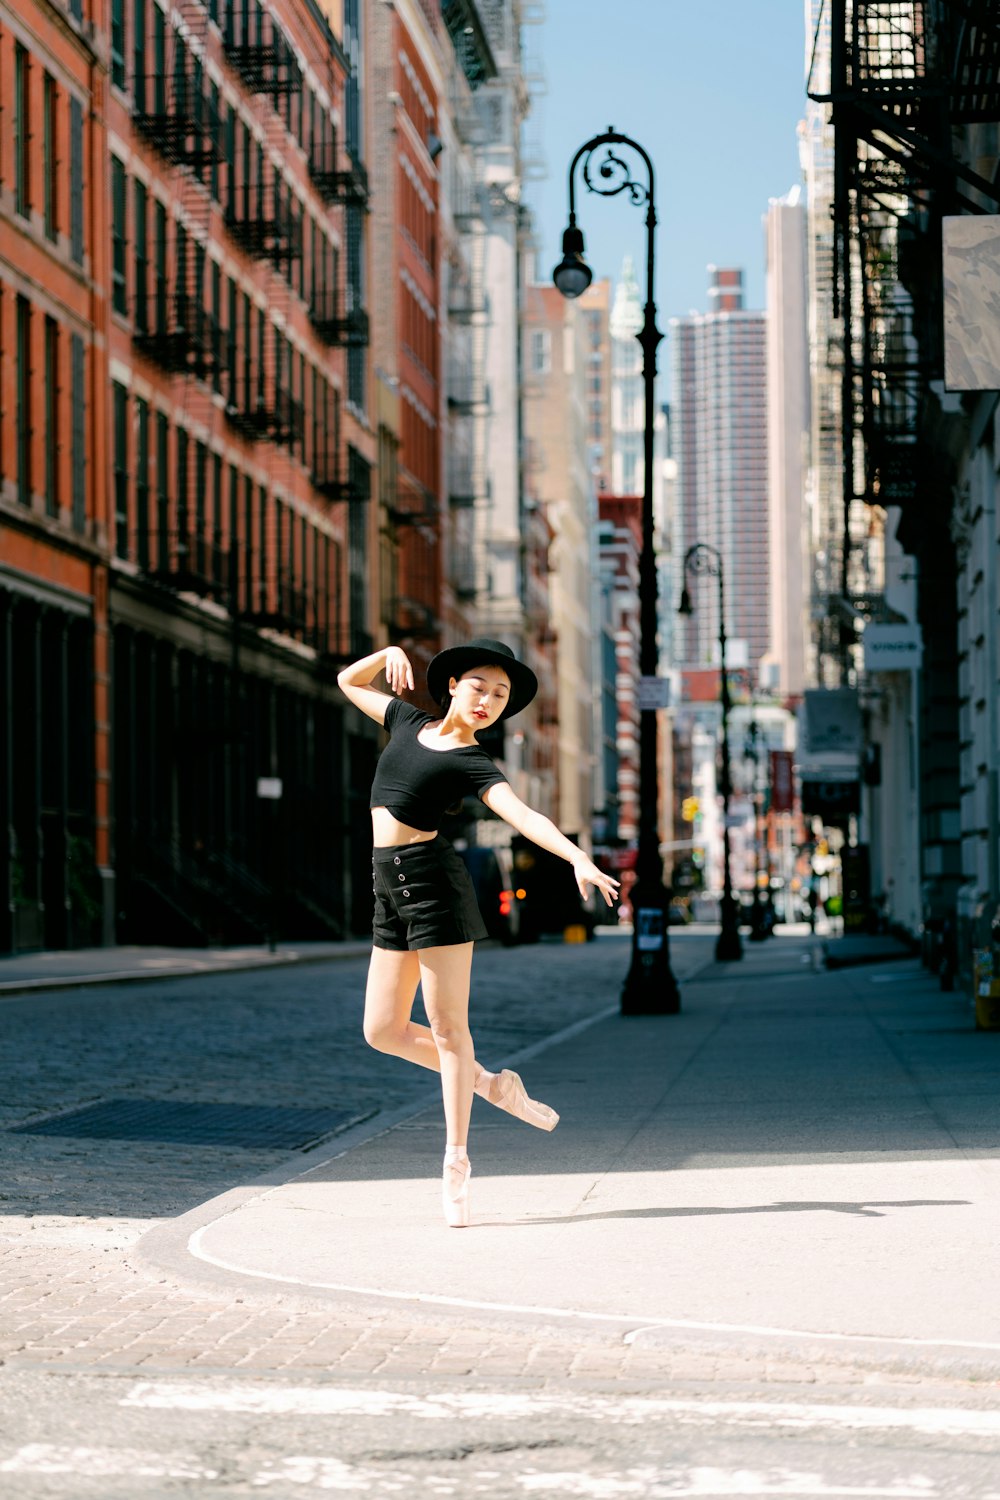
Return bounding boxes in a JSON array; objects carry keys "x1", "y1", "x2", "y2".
[{"x1": 670, "y1": 266, "x2": 769, "y2": 665}]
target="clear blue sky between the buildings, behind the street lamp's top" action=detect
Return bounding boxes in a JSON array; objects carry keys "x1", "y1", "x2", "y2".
[{"x1": 525, "y1": 0, "x2": 805, "y2": 319}]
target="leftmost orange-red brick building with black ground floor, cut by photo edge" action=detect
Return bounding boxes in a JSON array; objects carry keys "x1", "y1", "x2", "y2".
[{"x1": 0, "y1": 0, "x2": 109, "y2": 951}]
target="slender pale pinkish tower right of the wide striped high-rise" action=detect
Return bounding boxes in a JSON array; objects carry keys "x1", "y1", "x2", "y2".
[{"x1": 763, "y1": 188, "x2": 810, "y2": 696}]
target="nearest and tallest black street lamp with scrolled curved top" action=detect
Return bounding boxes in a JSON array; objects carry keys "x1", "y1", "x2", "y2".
[{"x1": 552, "y1": 126, "x2": 681, "y2": 1016}]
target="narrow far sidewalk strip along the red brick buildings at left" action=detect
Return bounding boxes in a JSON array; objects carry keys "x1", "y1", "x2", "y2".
[{"x1": 0, "y1": 939, "x2": 372, "y2": 998}]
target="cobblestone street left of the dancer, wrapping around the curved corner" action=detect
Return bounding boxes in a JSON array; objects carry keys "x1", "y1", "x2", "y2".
[{"x1": 0, "y1": 938, "x2": 722, "y2": 1377}]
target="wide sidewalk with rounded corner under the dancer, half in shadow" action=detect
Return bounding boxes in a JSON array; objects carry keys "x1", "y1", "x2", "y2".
[{"x1": 139, "y1": 938, "x2": 1000, "y2": 1379}]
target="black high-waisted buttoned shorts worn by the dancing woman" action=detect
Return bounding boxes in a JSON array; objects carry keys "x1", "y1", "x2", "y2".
[{"x1": 372, "y1": 834, "x2": 486, "y2": 953}]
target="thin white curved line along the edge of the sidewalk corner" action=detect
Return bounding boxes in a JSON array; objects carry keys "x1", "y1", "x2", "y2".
[{"x1": 187, "y1": 1224, "x2": 1000, "y2": 1355}]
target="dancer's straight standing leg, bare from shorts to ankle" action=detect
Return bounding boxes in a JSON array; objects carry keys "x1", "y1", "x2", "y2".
[{"x1": 418, "y1": 942, "x2": 477, "y2": 1148}]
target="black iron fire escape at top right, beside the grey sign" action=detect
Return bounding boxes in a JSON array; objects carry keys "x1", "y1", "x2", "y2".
[{"x1": 810, "y1": 0, "x2": 1000, "y2": 675}]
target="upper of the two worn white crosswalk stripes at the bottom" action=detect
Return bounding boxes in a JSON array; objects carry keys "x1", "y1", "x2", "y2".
[{"x1": 120, "y1": 1380, "x2": 1000, "y2": 1439}]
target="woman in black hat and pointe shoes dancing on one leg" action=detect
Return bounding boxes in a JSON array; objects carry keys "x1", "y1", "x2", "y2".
[{"x1": 337, "y1": 639, "x2": 618, "y2": 1229}]
